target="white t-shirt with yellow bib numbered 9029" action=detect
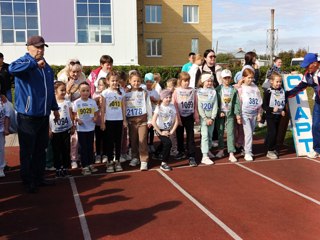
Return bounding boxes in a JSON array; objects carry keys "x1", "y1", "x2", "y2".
[{"x1": 72, "y1": 98, "x2": 98, "y2": 132}]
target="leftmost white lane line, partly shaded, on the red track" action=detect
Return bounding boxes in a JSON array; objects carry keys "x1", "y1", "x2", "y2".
[{"x1": 69, "y1": 177, "x2": 91, "y2": 240}]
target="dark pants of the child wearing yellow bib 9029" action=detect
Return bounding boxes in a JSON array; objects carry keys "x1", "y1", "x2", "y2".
[{"x1": 77, "y1": 131, "x2": 94, "y2": 167}]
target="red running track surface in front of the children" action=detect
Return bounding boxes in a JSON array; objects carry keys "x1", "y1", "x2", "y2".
[{"x1": 0, "y1": 138, "x2": 320, "y2": 240}]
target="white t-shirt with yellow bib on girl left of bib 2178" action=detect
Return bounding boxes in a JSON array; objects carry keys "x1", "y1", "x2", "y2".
[{"x1": 101, "y1": 89, "x2": 124, "y2": 121}]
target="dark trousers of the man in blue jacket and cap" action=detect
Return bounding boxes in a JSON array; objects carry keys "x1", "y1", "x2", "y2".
[{"x1": 17, "y1": 113, "x2": 49, "y2": 184}]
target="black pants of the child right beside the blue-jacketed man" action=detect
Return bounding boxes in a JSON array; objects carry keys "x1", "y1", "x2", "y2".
[{"x1": 51, "y1": 129, "x2": 71, "y2": 169}]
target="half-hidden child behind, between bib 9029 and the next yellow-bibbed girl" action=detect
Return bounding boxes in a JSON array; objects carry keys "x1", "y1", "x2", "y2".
[{"x1": 92, "y1": 77, "x2": 108, "y2": 163}]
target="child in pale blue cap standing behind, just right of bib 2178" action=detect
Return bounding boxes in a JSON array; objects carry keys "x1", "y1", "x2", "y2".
[{"x1": 144, "y1": 73, "x2": 160, "y2": 153}]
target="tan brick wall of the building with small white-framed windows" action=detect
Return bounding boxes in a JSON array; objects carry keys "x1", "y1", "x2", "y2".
[{"x1": 137, "y1": 0, "x2": 212, "y2": 66}]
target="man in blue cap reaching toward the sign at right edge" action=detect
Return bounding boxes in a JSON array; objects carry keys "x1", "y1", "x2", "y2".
[{"x1": 286, "y1": 53, "x2": 320, "y2": 158}]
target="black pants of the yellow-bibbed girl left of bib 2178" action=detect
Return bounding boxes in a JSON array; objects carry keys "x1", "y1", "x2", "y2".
[{"x1": 105, "y1": 120, "x2": 123, "y2": 161}]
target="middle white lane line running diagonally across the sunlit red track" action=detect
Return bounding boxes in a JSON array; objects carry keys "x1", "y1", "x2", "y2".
[{"x1": 157, "y1": 169, "x2": 242, "y2": 240}]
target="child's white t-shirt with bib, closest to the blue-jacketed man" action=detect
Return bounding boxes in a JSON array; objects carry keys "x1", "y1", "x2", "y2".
[{"x1": 49, "y1": 100, "x2": 72, "y2": 133}]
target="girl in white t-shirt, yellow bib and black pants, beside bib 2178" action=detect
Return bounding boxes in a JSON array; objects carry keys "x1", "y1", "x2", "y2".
[{"x1": 101, "y1": 71, "x2": 127, "y2": 173}]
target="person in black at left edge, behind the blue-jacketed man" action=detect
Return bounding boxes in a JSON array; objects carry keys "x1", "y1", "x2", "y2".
[{"x1": 0, "y1": 53, "x2": 13, "y2": 102}]
